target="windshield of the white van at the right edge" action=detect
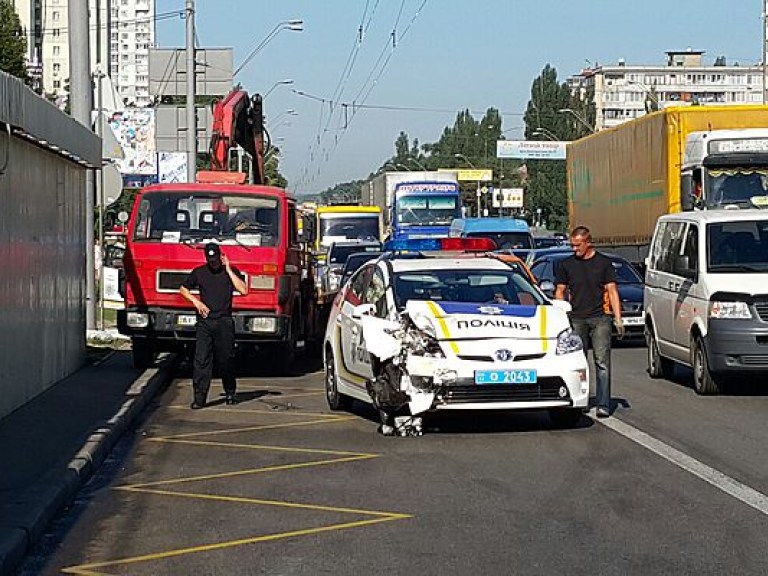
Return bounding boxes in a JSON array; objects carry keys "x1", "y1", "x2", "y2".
[{"x1": 707, "y1": 220, "x2": 768, "y2": 274}]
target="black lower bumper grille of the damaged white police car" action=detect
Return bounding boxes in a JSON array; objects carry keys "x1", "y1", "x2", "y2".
[{"x1": 438, "y1": 378, "x2": 570, "y2": 404}]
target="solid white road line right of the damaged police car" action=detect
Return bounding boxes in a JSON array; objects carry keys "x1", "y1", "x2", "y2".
[{"x1": 595, "y1": 418, "x2": 768, "y2": 516}]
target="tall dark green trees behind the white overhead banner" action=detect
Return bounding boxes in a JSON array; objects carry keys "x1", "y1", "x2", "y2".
[{"x1": 523, "y1": 64, "x2": 595, "y2": 230}]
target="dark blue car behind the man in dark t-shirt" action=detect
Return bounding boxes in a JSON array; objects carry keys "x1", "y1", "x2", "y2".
[{"x1": 531, "y1": 250, "x2": 645, "y2": 338}]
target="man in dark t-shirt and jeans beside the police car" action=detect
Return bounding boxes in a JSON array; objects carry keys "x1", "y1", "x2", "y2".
[{"x1": 555, "y1": 226, "x2": 624, "y2": 418}]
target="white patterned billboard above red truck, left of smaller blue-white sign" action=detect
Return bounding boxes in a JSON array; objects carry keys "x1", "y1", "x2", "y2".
[{"x1": 109, "y1": 108, "x2": 157, "y2": 175}]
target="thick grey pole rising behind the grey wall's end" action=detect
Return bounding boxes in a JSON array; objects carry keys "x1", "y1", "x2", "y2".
[{"x1": 67, "y1": 0, "x2": 96, "y2": 330}]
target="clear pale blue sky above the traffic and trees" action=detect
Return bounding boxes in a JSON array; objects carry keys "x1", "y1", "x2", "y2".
[{"x1": 155, "y1": 0, "x2": 763, "y2": 194}]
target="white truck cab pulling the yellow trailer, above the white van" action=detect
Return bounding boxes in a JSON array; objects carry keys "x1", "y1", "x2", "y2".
[{"x1": 680, "y1": 128, "x2": 768, "y2": 211}]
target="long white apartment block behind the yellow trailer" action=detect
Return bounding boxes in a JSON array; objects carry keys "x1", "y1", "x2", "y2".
[{"x1": 568, "y1": 49, "x2": 763, "y2": 130}]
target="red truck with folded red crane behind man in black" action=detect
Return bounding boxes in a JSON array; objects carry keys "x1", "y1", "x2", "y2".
[{"x1": 118, "y1": 90, "x2": 322, "y2": 368}]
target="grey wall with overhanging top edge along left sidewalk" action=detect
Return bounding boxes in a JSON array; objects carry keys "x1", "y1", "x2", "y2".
[{"x1": 0, "y1": 74, "x2": 99, "y2": 418}]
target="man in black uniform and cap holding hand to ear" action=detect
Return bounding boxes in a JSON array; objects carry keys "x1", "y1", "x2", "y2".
[{"x1": 180, "y1": 242, "x2": 248, "y2": 410}]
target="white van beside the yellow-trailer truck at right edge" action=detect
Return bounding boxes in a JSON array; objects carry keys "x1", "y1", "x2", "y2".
[{"x1": 645, "y1": 210, "x2": 768, "y2": 394}]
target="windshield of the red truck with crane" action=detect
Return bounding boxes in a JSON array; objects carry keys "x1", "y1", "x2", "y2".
[{"x1": 133, "y1": 191, "x2": 279, "y2": 246}]
